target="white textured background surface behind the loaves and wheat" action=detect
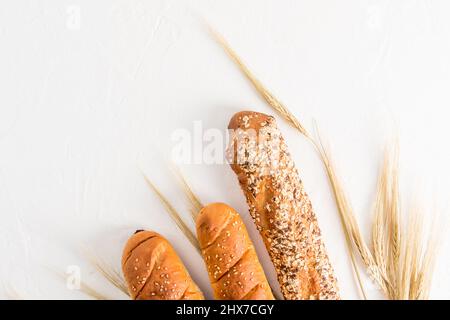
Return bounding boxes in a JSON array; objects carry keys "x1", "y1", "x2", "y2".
[{"x1": 0, "y1": 0, "x2": 450, "y2": 299}]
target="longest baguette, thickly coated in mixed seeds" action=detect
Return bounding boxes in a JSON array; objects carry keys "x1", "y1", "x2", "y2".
[{"x1": 227, "y1": 111, "x2": 339, "y2": 300}]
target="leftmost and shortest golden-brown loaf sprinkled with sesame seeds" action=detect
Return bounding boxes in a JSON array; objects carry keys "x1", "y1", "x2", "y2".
[{"x1": 122, "y1": 230, "x2": 204, "y2": 300}]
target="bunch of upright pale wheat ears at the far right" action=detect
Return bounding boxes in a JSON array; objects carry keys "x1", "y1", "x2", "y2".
[{"x1": 372, "y1": 142, "x2": 440, "y2": 300}]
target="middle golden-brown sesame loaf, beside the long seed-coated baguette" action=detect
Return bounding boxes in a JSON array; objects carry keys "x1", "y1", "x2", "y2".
[{"x1": 196, "y1": 203, "x2": 274, "y2": 300}]
